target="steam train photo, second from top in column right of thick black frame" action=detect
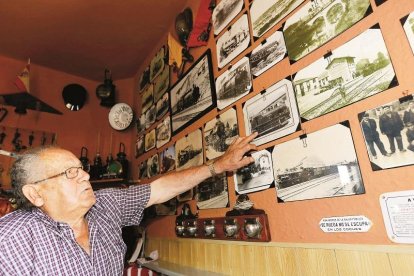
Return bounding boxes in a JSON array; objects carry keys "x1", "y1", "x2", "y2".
[{"x1": 216, "y1": 14, "x2": 250, "y2": 69}]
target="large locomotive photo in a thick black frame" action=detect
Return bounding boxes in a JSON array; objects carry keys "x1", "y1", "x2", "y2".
[{"x1": 170, "y1": 50, "x2": 216, "y2": 135}]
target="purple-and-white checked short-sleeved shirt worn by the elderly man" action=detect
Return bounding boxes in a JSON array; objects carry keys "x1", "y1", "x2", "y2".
[{"x1": 0, "y1": 185, "x2": 151, "y2": 276}]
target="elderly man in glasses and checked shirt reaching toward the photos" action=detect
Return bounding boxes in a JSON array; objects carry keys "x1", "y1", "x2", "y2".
[{"x1": 0, "y1": 133, "x2": 257, "y2": 276}]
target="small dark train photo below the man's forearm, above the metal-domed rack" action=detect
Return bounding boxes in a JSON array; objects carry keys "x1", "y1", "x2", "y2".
[{"x1": 195, "y1": 173, "x2": 229, "y2": 209}]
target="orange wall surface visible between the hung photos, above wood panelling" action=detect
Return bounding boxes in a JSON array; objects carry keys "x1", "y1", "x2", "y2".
[{"x1": 134, "y1": 0, "x2": 414, "y2": 244}]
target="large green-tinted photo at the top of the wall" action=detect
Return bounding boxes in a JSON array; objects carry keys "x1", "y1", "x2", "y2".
[{"x1": 283, "y1": 0, "x2": 372, "y2": 62}]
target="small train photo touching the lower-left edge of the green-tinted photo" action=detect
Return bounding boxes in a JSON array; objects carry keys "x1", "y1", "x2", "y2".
[{"x1": 249, "y1": 31, "x2": 287, "y2": 77}]
